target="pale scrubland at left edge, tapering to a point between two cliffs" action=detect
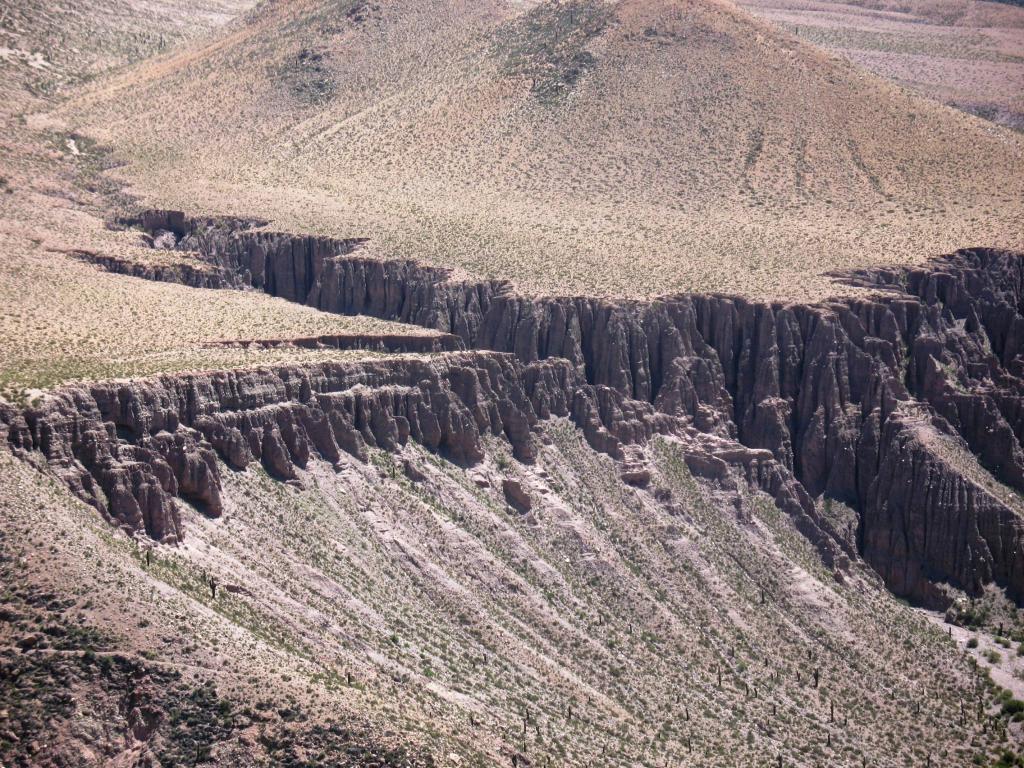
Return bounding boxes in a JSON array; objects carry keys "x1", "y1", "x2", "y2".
[{"x1": 0, "y1": 1, "x2": 448, "y2": 401}]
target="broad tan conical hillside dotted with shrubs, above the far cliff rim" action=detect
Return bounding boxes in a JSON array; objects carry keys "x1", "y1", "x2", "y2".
[{"x1": 59, "y1": 0, "x2": 1024, "y2": 298}]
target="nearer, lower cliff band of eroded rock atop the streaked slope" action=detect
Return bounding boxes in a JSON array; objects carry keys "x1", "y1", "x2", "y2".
[{"x1": 0, "y1": 352, "x2": 831, "y2": 562}]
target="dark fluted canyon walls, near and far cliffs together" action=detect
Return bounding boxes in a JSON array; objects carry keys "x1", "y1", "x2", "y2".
[{"x1": 9, "y1": 205, "x2": 1024, "y2": 608}]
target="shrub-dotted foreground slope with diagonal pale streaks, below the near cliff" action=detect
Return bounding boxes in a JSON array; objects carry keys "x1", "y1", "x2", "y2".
[{"x1": 0, "y1": 368, "x2": 1017, "y2": 768}]
